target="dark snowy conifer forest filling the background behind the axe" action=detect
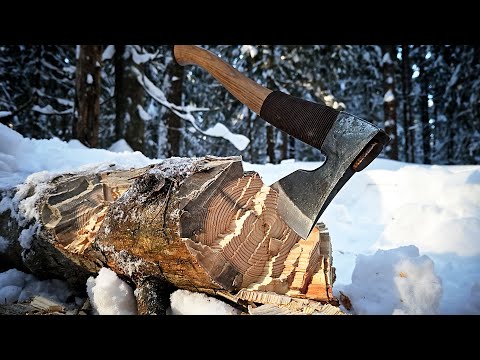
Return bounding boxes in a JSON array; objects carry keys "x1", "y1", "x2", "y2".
[{"x1": 0, "y1": 45, "x2": 480, "y2": 164}]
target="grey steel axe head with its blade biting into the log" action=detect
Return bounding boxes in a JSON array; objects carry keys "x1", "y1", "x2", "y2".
[{"x1": 271, "y1": 112, "x2": 390, "y2": 239}]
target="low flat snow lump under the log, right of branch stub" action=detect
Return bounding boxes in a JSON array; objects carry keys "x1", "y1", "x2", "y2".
[{"x1": 170, "y1": 290, "x2": 240, "y2": 315}]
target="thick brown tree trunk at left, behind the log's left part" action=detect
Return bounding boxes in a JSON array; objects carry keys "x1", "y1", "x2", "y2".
[{"x1": 73, "y1": 45, "x2": 102, "y2": 148}]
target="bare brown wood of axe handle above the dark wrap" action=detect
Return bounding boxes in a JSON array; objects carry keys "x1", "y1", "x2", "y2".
[{"x1": 173, "y1": 45, "x2": 272, "y2": 115}]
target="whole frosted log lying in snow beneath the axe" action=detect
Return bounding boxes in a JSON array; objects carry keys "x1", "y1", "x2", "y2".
[{"x1": 0, "y1": 157, "x2": 336, "y2": 313}]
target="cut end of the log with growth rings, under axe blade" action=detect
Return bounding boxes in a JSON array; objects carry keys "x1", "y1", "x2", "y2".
[{"x1": 180, "y1": 159, "x2": 333, "y2": 302}]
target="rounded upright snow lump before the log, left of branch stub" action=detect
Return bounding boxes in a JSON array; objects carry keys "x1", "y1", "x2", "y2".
[{"x1": 87, "y1": 268, "x2": 137, "y2": 315}]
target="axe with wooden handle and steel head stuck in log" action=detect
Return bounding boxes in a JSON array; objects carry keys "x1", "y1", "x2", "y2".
[{"x1": 173, "y1": 45, "x2": 390, "y2": 239}]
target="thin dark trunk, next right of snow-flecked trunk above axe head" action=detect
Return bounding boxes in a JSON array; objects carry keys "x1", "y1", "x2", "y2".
[{"x1": 402, "y1": 45, "x2": 415, "y2": 162}]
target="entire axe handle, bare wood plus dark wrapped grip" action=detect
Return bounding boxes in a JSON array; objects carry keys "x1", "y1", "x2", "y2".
[{"x1": 173, "y1": 45, "x2": 339, "y2": 149}]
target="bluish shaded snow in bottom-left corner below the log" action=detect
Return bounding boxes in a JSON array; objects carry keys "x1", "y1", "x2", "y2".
[{"x1": 0, "y1": 269, "x2": 71, "y2": 304}]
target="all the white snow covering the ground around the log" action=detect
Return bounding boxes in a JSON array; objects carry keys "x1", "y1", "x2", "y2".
[{"x1": 0, "y1": 124, "x2": 480, "y2": 314}]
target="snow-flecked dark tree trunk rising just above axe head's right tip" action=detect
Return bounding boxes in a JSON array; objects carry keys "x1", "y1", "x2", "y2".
[{"x1": 382, "y1": 45, "x2": 398, "y2": 160}]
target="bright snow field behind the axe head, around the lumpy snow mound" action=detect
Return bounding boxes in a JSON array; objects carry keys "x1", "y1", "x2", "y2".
[{"x1": 248, "y1": 159, "x2": 480, "y2": 314}]
